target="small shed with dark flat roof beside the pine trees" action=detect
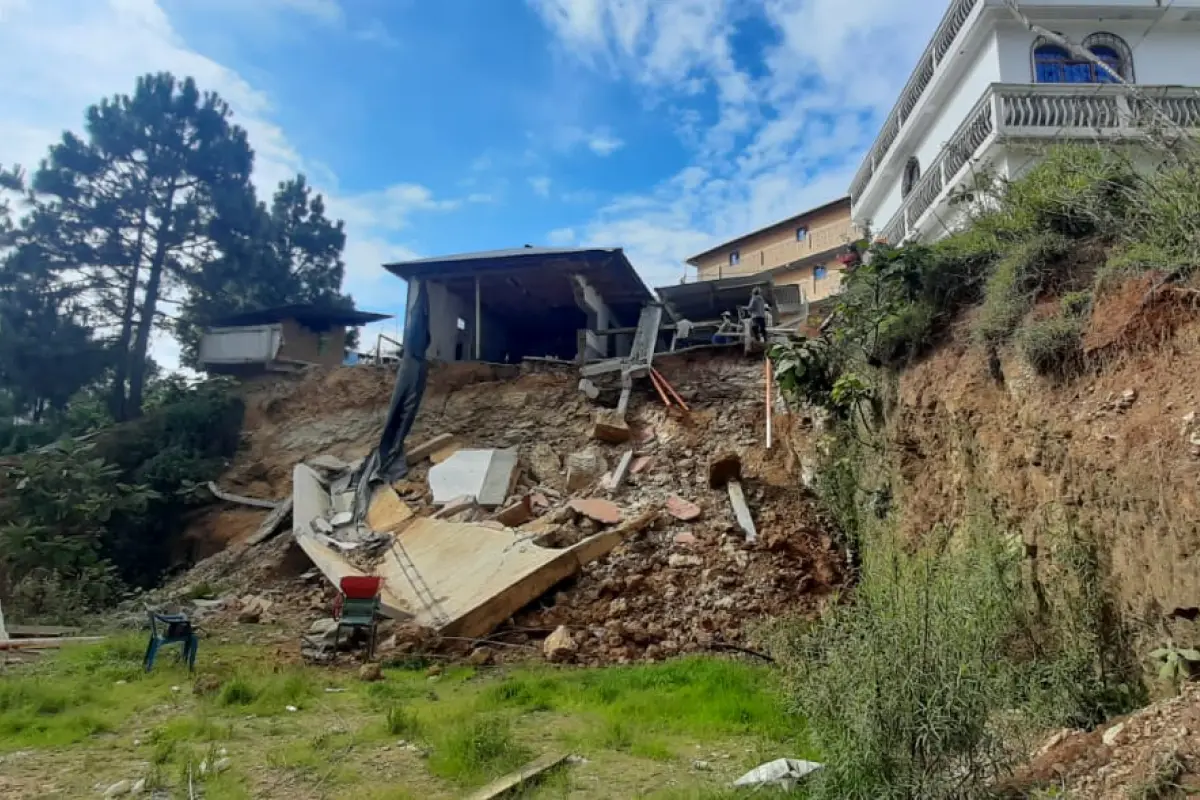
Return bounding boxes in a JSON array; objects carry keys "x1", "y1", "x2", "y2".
[{"x1": 200, "y1": 305, "x2": 390, "y2": 375}]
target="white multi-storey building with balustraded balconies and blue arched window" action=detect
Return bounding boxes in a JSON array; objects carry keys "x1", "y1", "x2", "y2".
[{"x1": 850, "y1": 0, "x2": 1200, "y2": 243}]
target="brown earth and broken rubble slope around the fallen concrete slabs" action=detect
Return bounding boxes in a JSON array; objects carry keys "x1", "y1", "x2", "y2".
[{"x1": 166, "y1": 353, "x2": 844, "y2": 663}]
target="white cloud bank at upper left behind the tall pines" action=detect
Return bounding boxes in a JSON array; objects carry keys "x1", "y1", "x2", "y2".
[{"x1": 0, "y1": 0, "x2": 432, "y2": 366}]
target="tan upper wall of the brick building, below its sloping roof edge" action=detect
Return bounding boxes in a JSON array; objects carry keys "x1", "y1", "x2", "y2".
[{"x1": 697, "y1": 201, "x2": 857, "y2": 281}]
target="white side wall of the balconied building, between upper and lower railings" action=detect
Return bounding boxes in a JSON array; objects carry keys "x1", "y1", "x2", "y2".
[{"x1": 856, "y1": 35, "x2": 1001, "y2": 233}]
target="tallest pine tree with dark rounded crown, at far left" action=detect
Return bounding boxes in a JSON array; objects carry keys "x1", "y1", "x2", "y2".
[{"x1": 29, "y1": 73, "x2": 253, "y2": 420}]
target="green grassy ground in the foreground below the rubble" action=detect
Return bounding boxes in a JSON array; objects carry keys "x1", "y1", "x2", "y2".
[{"x1": 0, "y1": 637, "x2": 809, "y2": 800}]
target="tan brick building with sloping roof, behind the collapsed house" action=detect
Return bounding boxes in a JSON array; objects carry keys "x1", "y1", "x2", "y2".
[{"x1": 688, "y1": 197, "x2": 858, "y2": 302}]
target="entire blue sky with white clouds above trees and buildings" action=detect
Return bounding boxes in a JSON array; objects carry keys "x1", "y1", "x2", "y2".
[{"x1": 0, "y1": 0, "x2": 944, "y2": 362}]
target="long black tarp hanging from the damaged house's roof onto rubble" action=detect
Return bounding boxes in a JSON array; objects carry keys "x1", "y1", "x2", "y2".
[{"x1": 354, "y1": 281, "x2": 430, "y2": 522}]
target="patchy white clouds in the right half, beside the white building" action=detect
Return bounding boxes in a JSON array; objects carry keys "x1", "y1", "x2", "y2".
[{"x1": 527, "y1": 0, "x2": 946, "y2": 292}]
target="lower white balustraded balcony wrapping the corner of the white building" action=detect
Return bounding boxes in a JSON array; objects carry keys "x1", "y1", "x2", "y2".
[{"x1": 880, "y1": 84, "x2": 1200, "y2": 242}]
